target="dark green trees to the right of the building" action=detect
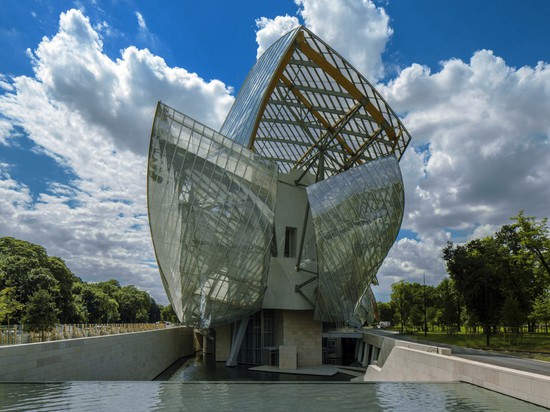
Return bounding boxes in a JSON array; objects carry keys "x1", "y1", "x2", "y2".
[{"x1": 379, "y1": 212, "x2": 550, "y2": 345}]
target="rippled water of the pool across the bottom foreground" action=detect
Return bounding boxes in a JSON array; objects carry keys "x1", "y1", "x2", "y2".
[{"x1": 0, "y1": 381, "x2": 545, "y2": 412}]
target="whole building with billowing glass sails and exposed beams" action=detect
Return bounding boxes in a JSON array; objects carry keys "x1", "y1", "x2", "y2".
[{"x1": 147, "y1": 27, "x2": 410, "y2": 365}]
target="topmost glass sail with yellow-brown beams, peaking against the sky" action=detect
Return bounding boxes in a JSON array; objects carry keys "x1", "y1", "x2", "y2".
[{"x1": 221, "y1": 27, "x2": 410, "y2": 176}]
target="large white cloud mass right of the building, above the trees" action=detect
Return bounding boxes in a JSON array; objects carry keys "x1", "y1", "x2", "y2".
[{"x1": 379, "y1": 50, "x2": 550, "y2": 296}]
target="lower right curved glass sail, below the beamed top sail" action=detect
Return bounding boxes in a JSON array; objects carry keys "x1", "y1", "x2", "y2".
[{"x1": 306, "y1": 155, "x2": 404, "y2": 324}]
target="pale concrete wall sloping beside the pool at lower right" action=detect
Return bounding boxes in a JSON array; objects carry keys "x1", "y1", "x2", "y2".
[{"x1": 364, "y1": 339, "x2": 550, "y2": 408}]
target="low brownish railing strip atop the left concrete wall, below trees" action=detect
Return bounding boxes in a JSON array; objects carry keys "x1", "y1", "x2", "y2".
[{"x1": 0, "y1": 322, "x2": 177, "y2": 345}]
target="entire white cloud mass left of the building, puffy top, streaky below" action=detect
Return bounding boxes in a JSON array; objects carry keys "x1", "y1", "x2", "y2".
[{"x1": 0, "y1": 10, "x2": 233, "y2": 303}]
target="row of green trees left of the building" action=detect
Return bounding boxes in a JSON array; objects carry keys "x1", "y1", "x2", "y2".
[{"x1": 0, "y1": 237, "x2": 176, "y2": 331}]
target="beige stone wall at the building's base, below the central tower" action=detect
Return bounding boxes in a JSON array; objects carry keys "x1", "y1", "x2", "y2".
[{"x1": 283, "y1": 310, "x2": 323, "y2": 367}]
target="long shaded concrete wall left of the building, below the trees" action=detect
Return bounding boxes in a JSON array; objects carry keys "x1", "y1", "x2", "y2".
[{"x1": 0, "y1": 327, "x2": 195, "y2": 382}]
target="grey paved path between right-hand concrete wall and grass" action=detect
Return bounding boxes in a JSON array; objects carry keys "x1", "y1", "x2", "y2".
[{"x1": 369, "y1": 329, "x2": 550, "y2": 376}]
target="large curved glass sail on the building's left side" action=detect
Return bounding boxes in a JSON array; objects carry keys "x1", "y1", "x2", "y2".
[{"x1": 147, "y1": 103, "x2": 277, "y2": 328}]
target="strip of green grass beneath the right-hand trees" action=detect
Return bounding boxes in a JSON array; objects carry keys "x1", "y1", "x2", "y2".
[{"x1": 396, "y1": 332, "x2": 550, "y2": 362}]
